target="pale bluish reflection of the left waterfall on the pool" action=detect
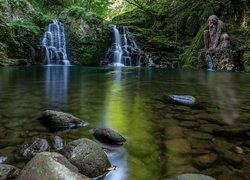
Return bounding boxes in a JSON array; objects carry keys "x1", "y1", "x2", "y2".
[{"x1": 45, "y1": 66, "x2": 70, "y2": 109}]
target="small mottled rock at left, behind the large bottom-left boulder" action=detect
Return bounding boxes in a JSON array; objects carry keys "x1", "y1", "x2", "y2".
[{"x1": 21, "y1": 138, "x2": 49, "y2": 157}]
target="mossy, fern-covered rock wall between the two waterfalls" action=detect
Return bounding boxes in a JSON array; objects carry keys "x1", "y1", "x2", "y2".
[{"x1": 60, "y1": 6, "x2": 111, "y2": 65}]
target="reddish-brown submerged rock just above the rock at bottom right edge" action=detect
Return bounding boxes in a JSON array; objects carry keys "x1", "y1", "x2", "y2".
[{"x1": 193, "y1": 153, "x2": 218, "y2": 169}]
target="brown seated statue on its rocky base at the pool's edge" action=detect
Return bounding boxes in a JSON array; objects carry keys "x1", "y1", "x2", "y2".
[{"x1": 198, "y1": 15, "x2": 243, "y2": 71}]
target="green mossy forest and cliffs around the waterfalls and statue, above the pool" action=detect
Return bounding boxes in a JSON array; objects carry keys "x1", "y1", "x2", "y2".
[{"x1": 0, "y1": 0, "x2": 250, "y2": 69}]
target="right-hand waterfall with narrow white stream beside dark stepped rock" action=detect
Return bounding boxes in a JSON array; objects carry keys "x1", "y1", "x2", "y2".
[{"x1": 105, "y1": 25, "x2": 147, "y2": 67}]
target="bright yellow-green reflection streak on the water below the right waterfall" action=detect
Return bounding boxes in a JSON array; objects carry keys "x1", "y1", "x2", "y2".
[{"x1": 104, "y1": 69, "x2": 159, "y2": 179}]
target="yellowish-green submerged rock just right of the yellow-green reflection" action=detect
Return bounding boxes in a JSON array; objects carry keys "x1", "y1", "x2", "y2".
[{"x1": 165, "y1": 139, "x2": 191, "y2": 154}]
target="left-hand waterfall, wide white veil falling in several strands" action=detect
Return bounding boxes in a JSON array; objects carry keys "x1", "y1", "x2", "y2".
[{"x1": 42, "y1": 19, "x2": 70, "y2": 65}]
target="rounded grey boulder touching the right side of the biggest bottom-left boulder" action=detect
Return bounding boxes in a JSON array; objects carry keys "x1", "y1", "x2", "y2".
[{"x1": 61, "y1": 138, "x2": 111, "y2": 177}]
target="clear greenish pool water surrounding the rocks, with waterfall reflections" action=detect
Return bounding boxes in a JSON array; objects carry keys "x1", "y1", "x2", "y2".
[{"x1": 0, "y1": 66, "x2": 250, "y2": 180}]
